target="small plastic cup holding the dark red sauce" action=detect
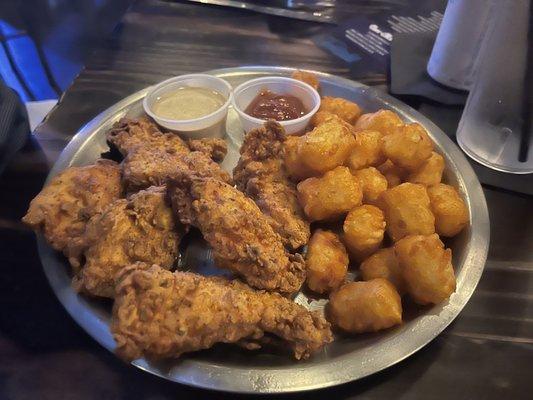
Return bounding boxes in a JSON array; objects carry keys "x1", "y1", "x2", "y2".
[{"x1": 232, "y1": 76, "x2": 320, "y2": 134}]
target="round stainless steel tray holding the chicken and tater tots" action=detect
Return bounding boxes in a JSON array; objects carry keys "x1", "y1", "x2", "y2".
[{"x1": 38, "y1": 67, "x2": 489, "y2": 393}]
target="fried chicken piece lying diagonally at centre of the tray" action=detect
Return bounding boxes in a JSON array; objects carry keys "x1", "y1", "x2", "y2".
[{"x1": 169, "y1": 174, "x2": 305, "y2": 294}]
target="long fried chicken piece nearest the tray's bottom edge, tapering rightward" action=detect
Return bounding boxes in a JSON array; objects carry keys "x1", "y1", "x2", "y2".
[{"x1": 111, "y1": 263, "x2": 333, "y2": 360}]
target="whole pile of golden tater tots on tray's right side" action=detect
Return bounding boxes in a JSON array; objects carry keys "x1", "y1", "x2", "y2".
[{"x1": 285, "y1": 93, "x2": 469, "y2": 333}]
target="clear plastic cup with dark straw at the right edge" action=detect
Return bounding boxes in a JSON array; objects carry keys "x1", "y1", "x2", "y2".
[{"x1": 457, "y1": 0, "x2": 533, "y2": 174}]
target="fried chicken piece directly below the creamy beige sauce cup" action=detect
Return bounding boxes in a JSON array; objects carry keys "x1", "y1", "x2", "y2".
[{"x1": 107, "y1": 118, "x2": 231, "y2": 192}]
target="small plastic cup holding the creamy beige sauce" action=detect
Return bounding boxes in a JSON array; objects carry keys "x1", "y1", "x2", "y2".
[{"x1": 143, "y1": 74, "x2": 233, "y2": 139}]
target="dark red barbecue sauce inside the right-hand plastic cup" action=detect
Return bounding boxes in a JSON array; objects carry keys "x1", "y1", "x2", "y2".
[{"x1": 245, "y1": 89, "x2": 307, "y2": 121}]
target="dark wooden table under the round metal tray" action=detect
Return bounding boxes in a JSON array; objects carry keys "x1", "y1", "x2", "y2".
[{"x1": 0, "y1": 0, "x2": 533, "y2": 400}]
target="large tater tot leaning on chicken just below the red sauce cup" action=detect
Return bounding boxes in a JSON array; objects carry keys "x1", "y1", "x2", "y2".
[{"x1": 285, "y1": 119, "x2": 355, "y2": 180}]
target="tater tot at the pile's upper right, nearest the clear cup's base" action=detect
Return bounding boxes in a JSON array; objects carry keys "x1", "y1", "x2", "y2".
[{"x1": 383, "y1": 122, "x2": 433, "y2": 171}]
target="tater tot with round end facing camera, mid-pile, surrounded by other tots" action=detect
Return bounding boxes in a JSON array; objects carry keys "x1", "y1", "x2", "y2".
[{"x1": 342, "y1": 204, "x2": 385, "y2": 261}]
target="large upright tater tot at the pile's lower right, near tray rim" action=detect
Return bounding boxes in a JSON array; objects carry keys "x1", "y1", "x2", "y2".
[{"x1": 394, "y1": 234, "x2": 455, "y2": 304}]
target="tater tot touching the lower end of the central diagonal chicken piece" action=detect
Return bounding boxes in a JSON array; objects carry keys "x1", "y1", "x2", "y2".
[{"x1": 305, "y1": 229, "x2": 349, "y2": 294}]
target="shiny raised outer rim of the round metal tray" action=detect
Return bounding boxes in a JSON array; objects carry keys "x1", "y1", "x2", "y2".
[{"x1": 38, "y1": 66, "x2": 490, "y2": 393}]
